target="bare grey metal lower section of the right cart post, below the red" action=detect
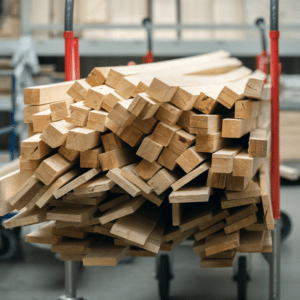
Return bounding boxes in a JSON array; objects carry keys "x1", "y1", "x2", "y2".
[{"x1": 269, "y1": 220, "x2": 281, "y2": 300}]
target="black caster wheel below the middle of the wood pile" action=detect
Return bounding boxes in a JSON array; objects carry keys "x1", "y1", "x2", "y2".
[{"x1": 157, "y1": 254, "x2": 172, "y2": 300}]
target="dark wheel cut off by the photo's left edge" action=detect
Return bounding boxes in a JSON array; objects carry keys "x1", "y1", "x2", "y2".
[{"x1": 0, "y1": 229, "x2": 19, "y2": 260}]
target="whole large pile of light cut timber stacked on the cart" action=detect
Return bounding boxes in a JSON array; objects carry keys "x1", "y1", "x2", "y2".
[{"x1": 0, "y1": 51, "x2": 274, "y2": 267}]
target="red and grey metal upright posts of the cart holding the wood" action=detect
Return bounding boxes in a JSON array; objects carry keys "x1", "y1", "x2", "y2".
[{"x1": 60, "y1": 0, "x2": 281, "y2": 300}]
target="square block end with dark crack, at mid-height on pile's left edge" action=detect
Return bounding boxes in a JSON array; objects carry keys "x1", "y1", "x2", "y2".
[{"x1": 21, "y1": 133, "x2": 53, "y2": 160}]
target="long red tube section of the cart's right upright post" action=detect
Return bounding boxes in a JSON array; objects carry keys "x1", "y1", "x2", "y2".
[{"x1": 270, "y1": 31, "x2": 280, "y2": 219}]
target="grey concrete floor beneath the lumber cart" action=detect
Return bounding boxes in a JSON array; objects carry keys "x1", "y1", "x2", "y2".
[{"x1": 0, "y1": 186, "x2": 300, "y2": 300}]
